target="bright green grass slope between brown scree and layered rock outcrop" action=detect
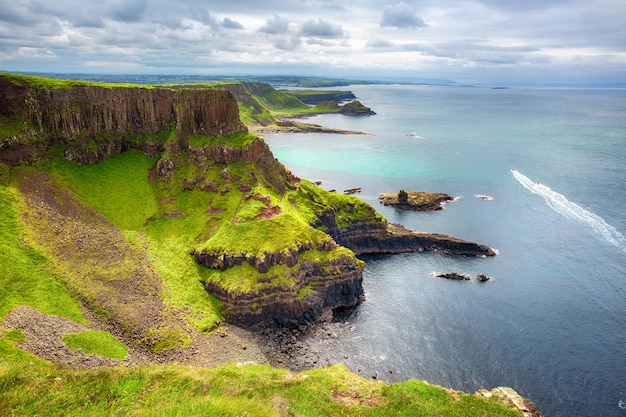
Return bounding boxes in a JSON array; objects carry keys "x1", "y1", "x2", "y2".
[{"x1": 46, "y1": 150, "x2": 222, "y2": 334}]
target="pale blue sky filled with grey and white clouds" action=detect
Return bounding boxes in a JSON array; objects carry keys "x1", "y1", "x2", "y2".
[{"x1": 0, "y1": 0, "x2": 626, "y2": 83}]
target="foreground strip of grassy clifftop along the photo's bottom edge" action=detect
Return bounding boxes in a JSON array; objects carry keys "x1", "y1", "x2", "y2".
[{"x1": 0, "y1": 363, "x2": 520, "y2": 417}]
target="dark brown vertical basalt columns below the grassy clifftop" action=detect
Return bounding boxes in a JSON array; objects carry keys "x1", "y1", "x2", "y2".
[{"x1": 0, "y1": 76, "x2": 247, "y2": 163}]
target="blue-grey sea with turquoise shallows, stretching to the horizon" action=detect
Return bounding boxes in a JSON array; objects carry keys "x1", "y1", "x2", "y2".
[{"x1": 265, "y1": 85, "x2": 626, "y2": 416}]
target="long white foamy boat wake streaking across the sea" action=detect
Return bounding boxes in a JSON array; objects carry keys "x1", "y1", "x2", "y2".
[{"x1": 511, "y1": 169, "x2": 626, "y2": 252}]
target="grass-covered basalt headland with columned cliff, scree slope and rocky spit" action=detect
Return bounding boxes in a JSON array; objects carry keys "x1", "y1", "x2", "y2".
[{"x1": 0, "y1": 75, "x2": 494, "y2": 338}]
